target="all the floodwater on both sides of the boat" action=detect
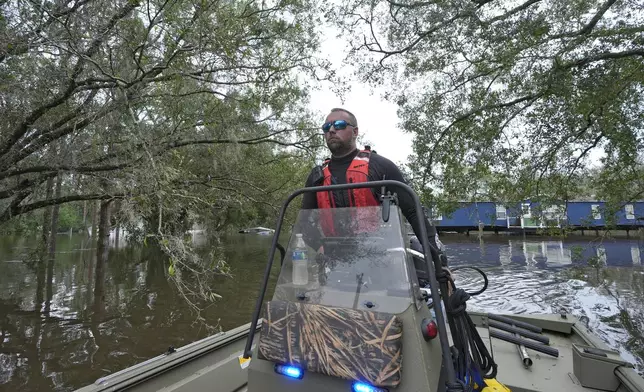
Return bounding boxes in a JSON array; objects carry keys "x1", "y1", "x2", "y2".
[{"x1": 0, "y1": 231, "x2": 644, "y2": 391}]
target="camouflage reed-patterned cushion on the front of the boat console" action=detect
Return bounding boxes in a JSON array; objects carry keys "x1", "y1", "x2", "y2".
[{"x1": 258, "y1": 301, "x2": 403, "y2": 387}]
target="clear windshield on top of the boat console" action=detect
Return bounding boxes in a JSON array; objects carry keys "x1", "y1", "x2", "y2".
[{"x1": 273, "y1": 206, "x2": 417, "y2": 313}]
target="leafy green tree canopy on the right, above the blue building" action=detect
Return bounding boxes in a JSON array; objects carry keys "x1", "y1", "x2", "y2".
[{"x1": 334, "y1": 0, "x2": 644, "y2": 210}]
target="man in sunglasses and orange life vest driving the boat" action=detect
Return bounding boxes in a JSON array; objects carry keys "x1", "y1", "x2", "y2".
[{"x1": 302, "y1": 108, "x2": 438, "y2": 280}]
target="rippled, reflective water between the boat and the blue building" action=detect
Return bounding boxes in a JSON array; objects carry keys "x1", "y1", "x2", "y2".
[{"x1": 445, "y1": 237, "x2": 644, "y2": 374}]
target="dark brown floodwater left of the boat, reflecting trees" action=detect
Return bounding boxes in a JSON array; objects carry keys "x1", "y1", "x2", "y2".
[{"x1": 0, "y1": 236, "x2": 280, "y2": 391}]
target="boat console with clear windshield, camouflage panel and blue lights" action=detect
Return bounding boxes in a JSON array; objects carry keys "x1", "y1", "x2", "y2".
[{"x1": 243, "y1": 184, "x2": 451, "y2": 392}]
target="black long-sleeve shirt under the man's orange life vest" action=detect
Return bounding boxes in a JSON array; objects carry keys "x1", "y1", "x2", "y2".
[{"x1": 302, "y1": 149, "x2": 436, "y2": 250}]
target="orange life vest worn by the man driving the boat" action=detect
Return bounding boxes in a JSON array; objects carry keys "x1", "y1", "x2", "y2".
[{"x1": 316, "y1": 150, "x2": 380, "y2": 237}]
